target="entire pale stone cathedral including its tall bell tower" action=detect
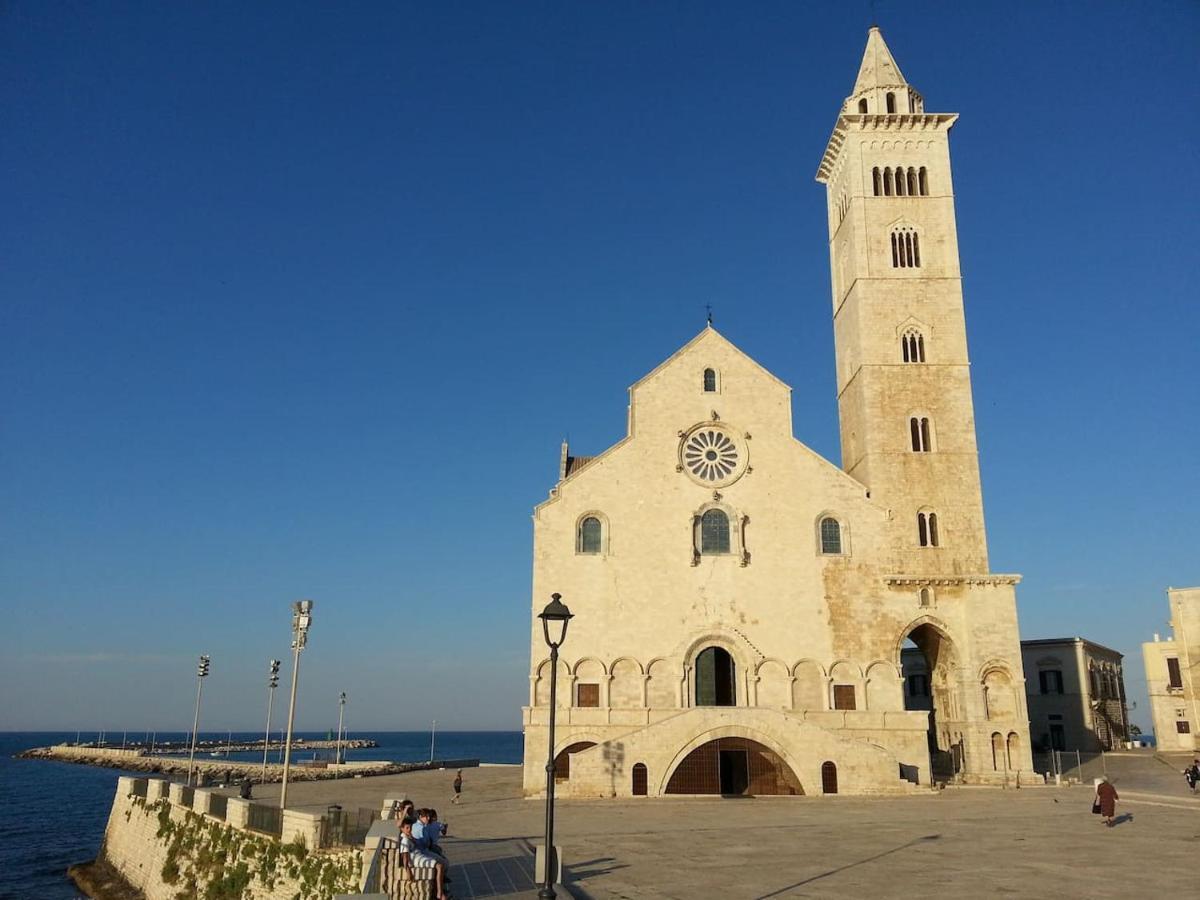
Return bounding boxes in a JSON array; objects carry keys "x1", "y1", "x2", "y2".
[{"x1": 524, "y1": 28, "x2": 1040, "y2": 797}]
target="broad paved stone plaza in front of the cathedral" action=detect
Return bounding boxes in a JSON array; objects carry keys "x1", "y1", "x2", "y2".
[{"x1": 246, "y1": 754, "x2": 1200, "y2": 900}]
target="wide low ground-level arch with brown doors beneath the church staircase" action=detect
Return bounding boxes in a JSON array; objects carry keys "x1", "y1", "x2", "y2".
[{"x1": 665, "y1": 738, "x2": 804, "y2": 797}]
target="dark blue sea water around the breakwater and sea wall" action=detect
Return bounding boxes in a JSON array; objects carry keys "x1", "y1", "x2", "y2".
[{"x1": 0, "y1": 731, "x2": 523, "y2": 900}]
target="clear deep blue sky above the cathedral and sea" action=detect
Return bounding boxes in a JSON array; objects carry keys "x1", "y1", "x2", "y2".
[{"x1": 0, "y1": 0, "x2": 1200, "y2": 731}]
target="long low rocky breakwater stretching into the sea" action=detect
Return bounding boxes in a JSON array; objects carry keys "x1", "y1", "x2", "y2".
[{"x1": 17, "y1": 743, "x2": 427, "y2": 784}]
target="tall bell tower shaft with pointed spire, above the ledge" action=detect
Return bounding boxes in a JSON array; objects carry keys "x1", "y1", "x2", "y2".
[{"x1": 816, "y1": 28, "x2": 988, "y2": 575}]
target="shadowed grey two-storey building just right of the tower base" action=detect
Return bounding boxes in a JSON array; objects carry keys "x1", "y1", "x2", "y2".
[{"x1": 1021, "y1": 637, "x2": 1129, "y2": 751}]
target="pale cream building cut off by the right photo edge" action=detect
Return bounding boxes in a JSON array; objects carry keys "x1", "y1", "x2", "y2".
[{"x1": 1141, "y1": 588, "x2": 1200, "y2": 750}]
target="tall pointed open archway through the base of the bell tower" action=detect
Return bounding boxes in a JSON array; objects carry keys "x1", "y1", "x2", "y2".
[{"x1": 900, "y1": 622, "x2": 962, "y2": 781}]
